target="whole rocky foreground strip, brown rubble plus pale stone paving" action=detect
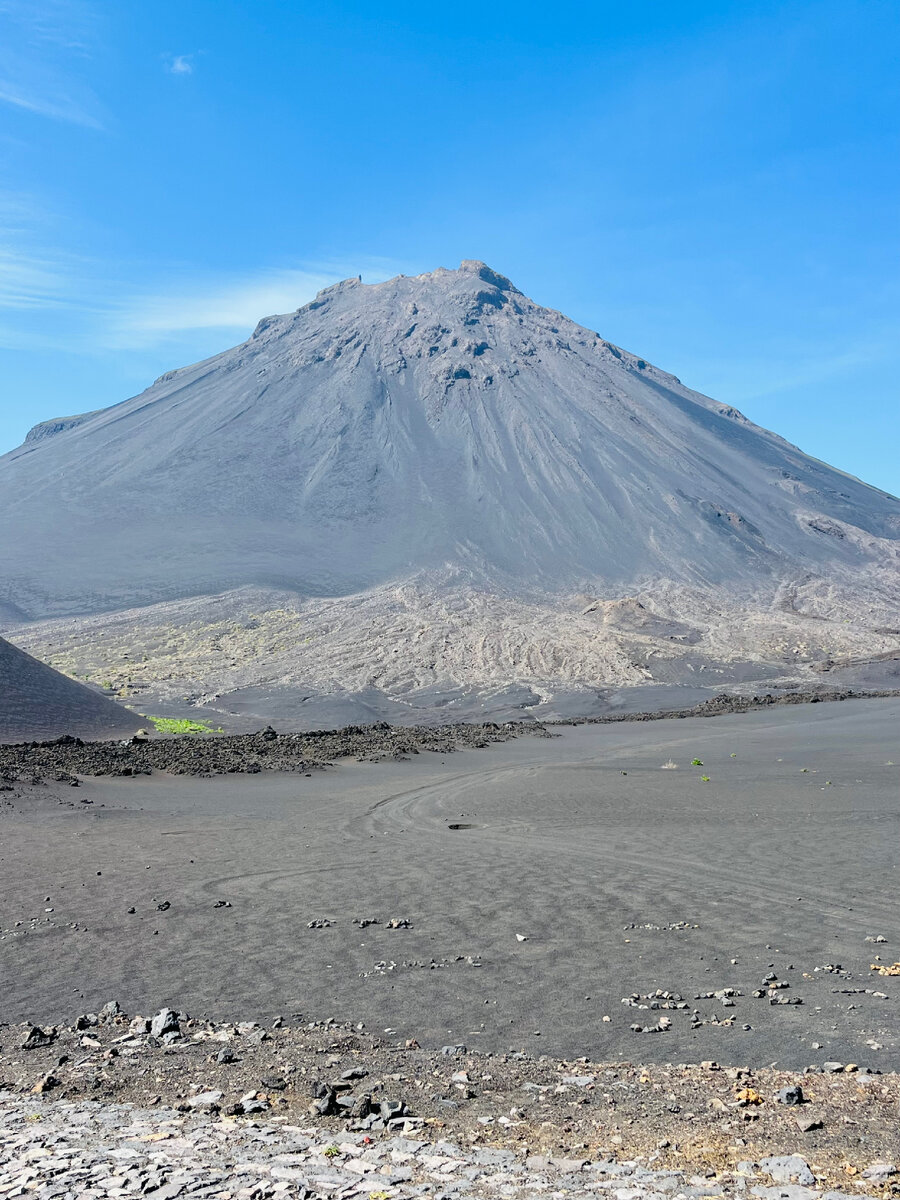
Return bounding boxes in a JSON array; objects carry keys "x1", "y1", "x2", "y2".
[{"x1": 0, "y1": 1002, "x2": 900, "y2": 1200}]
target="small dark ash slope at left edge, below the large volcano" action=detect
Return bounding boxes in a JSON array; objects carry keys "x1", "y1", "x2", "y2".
[{"x1": 0, "y1": 637, "x2": 140, "y2": 742}]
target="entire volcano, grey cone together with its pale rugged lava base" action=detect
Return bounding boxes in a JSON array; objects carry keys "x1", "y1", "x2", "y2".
[{"x1": 0, "y1": 262, "x2": 900, "y2": 716}]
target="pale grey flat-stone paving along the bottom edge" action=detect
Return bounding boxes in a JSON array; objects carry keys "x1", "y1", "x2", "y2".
[{"x1": 0, "y1": 1093, "x2": 896, "y2": 1200}]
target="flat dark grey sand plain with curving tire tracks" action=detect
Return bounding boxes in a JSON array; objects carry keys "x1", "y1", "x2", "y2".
[{"x1": 0, "y1": 700, "x2": 900, "y2": 1070}]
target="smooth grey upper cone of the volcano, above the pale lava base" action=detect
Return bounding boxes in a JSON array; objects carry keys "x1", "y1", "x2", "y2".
[{"x1": 0, "y1": 263, "x2": 900, "y2": 618}]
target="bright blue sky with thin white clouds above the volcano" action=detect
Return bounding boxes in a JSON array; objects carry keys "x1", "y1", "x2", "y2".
[{"x1": 0, "y1": 0, "x2": 900, "y2": 493}]
